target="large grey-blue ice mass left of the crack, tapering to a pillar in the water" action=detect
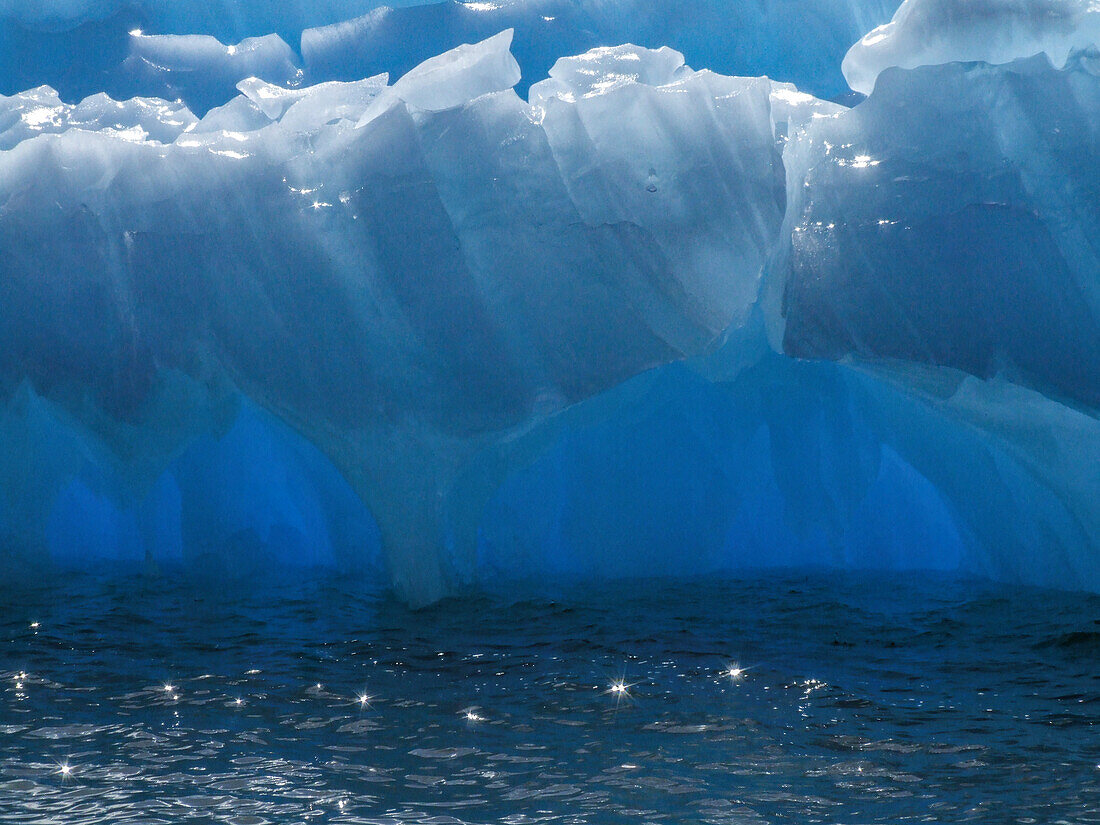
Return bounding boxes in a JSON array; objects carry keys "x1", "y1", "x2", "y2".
[{"x1": 0, "y1": 37, "x2": 800, "y2": 601}]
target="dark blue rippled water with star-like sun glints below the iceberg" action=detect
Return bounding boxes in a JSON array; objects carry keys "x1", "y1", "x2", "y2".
[{"x1": 0, "y1": 575, "x2": 1100, "y2": 825}]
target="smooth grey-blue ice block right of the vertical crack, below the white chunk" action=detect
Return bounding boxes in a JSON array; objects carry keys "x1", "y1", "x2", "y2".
[{"x1": 774, "y1": 57, "x2": 1100, "y2": 405}]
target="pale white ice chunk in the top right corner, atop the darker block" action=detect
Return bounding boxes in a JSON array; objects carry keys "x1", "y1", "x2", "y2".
[{"x1": 844, "y1": 0, "x2": 1100, "y2": 95}]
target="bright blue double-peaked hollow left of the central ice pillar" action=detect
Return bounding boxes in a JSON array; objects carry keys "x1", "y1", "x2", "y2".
[{"x1": 0, "y1": 373, "x2": 385, "y2": 584}]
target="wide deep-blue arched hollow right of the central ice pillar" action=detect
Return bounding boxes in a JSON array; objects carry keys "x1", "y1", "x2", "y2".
[{"x1": 479, "y1": 355, "x2": 970, "y2": 581}]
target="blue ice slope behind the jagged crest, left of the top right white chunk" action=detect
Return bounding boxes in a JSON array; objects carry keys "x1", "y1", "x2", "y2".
[{"x1": 301, "y1": 0, "x2": 897, "y2": 97}]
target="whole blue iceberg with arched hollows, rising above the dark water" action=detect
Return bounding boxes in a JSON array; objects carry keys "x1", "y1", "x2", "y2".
[{"x1": 0, "y1": 0, "x2": 1100, "y2": 603}]
